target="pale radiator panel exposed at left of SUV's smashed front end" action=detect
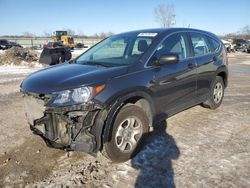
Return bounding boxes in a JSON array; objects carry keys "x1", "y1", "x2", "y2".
[{"x1": 24, "y1": 95, "x2": 45, "y2": 125}]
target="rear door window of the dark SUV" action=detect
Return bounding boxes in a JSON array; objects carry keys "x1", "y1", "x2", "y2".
[{"x1": 190, "y1": 33, "x2": 210, "y2": 56}]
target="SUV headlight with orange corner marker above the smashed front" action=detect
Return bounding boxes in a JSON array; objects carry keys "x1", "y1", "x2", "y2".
[{"x1": 52, "y1": 84, "x2": 105, "y2": 106}]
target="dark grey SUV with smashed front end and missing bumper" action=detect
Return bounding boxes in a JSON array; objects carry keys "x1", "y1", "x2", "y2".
[{"x1": 21, "y1": 28, "x2": 228, "y2": 162}]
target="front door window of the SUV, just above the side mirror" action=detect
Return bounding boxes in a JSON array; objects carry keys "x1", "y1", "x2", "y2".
[{"x1": 156, "y1": 34, "x2": 188, "y2": 60}]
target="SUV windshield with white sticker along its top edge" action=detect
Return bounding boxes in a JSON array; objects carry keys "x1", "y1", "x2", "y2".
[{"x1": 76, "y1": 33, "x2": 157, "y2": 66}]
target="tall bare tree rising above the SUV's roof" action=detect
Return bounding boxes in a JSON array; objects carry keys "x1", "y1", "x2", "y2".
[{"x1": 154, "y1": 4, "x2": 175, "y2": 27}]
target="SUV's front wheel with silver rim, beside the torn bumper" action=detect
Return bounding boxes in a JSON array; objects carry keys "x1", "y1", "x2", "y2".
[{"x1": 102, "y1": 105, "x2": 149, "y2": 162}]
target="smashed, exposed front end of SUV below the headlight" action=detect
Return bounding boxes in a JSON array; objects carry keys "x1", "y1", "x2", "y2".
[{"x1": 24, "y1": 93, "x2": 106, "y2": 155}]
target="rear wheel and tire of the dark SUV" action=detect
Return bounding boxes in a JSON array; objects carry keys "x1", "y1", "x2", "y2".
[{"x1": 202, "y1": 76, "x2": 225, "y2": 109}]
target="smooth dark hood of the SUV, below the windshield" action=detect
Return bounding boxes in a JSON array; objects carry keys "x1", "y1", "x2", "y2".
[{"x1": 21, "y1": 64, "x2": 127, "y2": 94}]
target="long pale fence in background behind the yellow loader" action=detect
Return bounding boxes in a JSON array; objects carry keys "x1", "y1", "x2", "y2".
[{"x1": 0, "y1": 37, "x2": 101, "y2": 47}]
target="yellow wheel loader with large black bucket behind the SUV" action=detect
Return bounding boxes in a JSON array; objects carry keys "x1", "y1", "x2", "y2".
[{"x1": 39, "y1": 31, "x2": 84, "y2": 65}]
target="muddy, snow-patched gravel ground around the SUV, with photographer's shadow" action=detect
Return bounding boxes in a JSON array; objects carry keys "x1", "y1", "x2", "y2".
[{"x1": 0, "y1": 53, "x2": 250, "y2": 188}]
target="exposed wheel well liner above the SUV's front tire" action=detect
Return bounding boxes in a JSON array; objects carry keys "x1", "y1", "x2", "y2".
[{"x1": 124, "y1": 96, "x2": 154, "y2": 127}]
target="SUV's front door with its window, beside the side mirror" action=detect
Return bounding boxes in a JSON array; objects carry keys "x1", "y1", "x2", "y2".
[{"x1": 150, "y1": 32, "x2": 196, "y2": 115}]
